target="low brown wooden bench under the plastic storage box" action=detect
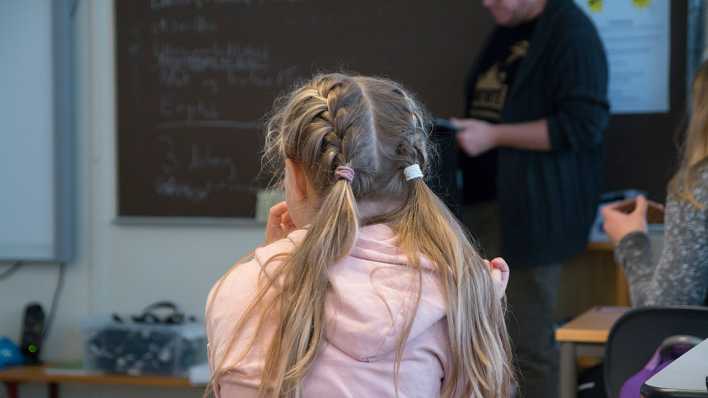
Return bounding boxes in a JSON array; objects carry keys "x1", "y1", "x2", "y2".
[{"x1": 0, "y1": 366, "x2": 204, "y2": 398}]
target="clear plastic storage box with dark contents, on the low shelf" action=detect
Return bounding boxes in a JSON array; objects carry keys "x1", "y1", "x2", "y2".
[{"x1": 81, "y1": 317, "x2": 207, "y2": 376}]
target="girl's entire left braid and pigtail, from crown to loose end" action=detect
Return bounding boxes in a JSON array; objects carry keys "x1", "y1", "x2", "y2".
[{"x1": 260, "y1": 76, "x2": 365, "y2": 398}]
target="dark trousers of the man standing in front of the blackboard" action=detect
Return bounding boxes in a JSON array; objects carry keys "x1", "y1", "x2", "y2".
[{"x1": 463, "y1": 202, "x2": 561, "y2": 398}]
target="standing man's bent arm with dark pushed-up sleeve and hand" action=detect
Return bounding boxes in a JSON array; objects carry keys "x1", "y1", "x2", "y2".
[{"x1": 452, "y1": 27, "x2": 609, "y2": 156}]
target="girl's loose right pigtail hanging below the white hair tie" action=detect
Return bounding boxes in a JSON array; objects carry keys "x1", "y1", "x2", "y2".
[{"x1": 399, "y1": 179, "x2": 514, "y2": 398}]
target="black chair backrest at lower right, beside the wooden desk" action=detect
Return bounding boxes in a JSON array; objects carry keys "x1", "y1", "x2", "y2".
[{"x1": 605, "y1": 306, "x2": 708, "y2": 398}]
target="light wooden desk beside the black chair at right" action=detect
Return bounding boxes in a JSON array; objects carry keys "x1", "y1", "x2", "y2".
[{"x1": 556, "y1": 307, "x2": 629, "y2": 398}]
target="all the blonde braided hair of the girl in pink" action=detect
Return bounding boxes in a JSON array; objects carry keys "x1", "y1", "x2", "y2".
[{"x1": 210, "y1": 74, "x2": 513, "y2": 398}]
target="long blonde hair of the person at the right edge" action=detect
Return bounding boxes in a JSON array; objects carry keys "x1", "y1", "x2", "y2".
[{"x1": 669, "y1": 61, "x2": 708, "y2": 209}]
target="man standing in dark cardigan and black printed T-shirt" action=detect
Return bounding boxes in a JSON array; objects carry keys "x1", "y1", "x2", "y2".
[{"x1": 453, "y1": 0, "x2": 609, "y2": 398}]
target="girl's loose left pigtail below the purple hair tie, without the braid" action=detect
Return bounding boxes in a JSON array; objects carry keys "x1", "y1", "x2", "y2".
[{"x1": 261, "y1": 176, "x2": 358, "y2": 397}]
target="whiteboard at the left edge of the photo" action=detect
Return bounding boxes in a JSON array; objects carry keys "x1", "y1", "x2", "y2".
[{"x1": 0, "y1": 0, "x2": 73, "y2": 261}]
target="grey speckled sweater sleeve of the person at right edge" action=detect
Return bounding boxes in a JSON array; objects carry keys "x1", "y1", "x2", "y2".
[{"x1": 615, "y1": 198, "x2": 708, "y2": 306}]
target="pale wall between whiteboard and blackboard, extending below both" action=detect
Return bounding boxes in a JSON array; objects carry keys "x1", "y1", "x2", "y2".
[{"x1": 0, "y1": 0, "x2": 263, "y2": 398}]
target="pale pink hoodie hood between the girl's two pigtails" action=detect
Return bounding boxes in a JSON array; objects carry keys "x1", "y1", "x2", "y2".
[{"x1": 262, "y1": 224, "x2": 446, "y2": 362}]
